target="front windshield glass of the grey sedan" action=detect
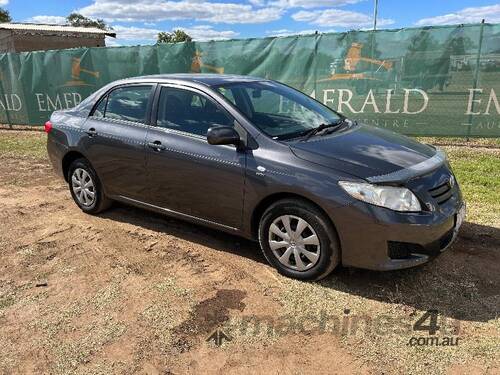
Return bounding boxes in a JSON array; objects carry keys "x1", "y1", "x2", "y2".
[{"x1": 215, "y1": 81, "x2": 341, "y2": 139}]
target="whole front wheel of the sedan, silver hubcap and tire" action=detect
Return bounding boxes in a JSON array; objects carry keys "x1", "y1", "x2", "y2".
[{"x1": 259, "y1": 199, "x2": 340, "y2": 280}]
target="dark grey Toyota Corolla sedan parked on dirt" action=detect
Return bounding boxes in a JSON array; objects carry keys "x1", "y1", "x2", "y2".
[{"x1": 45, "y1": 74, "x2": 465, "y2": 279}]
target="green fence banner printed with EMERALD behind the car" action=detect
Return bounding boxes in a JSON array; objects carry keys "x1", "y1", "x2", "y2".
[{"x1": 0, "y1": 24, "x2": 500, "y2": 137}]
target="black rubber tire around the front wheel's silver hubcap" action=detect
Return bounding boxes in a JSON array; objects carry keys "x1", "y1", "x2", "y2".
[{"x1": 258, "y1": 199, "x2": 340, "y2": 280}]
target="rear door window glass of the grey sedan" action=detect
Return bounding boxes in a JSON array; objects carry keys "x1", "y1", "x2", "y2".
[{"x1": 102, "y1": 85, "x2": 152, "y2": 123}]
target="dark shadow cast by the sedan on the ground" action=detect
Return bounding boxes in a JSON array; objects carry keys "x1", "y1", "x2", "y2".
[{"x1": 100, "y1": 203, "x2": 500, "y2": 322}]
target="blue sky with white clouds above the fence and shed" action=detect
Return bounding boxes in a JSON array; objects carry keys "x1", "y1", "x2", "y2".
[{"x1": 0, "y1": 0, "x2": 500, "y2": 45}]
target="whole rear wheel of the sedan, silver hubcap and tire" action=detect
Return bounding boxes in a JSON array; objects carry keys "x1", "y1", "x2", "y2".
[{"x1": 68, "y1": 159, "x2": 111, "y2": 214}]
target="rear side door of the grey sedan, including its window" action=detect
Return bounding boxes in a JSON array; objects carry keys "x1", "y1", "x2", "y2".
[{"x1": 84, "y1": 84, "x2": 154, "y2": 199}]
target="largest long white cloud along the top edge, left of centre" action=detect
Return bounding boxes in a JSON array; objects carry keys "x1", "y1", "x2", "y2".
[{"x1": 78, "y1": 0, "x2": 283, "y2": 23}]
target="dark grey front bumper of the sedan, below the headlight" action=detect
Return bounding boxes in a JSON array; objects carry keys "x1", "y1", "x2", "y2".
[{"x1": 331, "y1": 173, "x2": 465, "y2": 271}]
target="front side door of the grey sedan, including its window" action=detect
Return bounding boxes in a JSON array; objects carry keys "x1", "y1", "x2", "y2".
[{"x1": 146, "y1": 85, "x2": 245, "y2": 229}]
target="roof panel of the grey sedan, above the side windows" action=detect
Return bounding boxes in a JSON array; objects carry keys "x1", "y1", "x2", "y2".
[{"x1": 126, "y1": 73, "x2": 265, "y2": 86}]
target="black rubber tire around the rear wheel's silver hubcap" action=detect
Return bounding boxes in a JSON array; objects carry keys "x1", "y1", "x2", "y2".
[{"x1": 68, "y1": 158, "x2": 112, "y2": 215}]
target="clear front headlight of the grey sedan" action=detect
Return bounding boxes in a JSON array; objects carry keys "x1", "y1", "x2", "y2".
[{"x1": 339, "y1": 181, "x2": 421, "y2": 211}]
